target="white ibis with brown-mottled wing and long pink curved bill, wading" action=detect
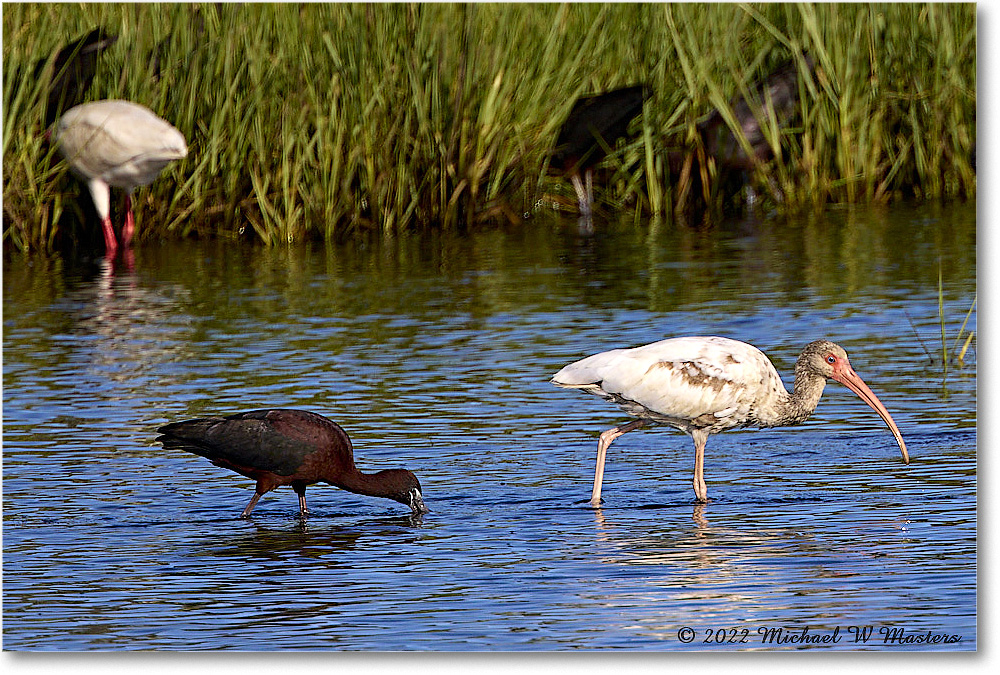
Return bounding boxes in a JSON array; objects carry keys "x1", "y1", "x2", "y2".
[{"x1": 552, "y1": 337, "x2": 910, "y2": 507}]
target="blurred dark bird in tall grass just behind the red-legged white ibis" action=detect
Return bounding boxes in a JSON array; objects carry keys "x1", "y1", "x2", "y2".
[{"x1": 35, "y1": 28, "x2": 118, "y2": 127}]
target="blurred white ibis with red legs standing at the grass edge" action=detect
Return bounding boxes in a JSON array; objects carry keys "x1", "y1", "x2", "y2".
[{"x1": 55, "y1": 100, "x2": 187, "y2": 258}]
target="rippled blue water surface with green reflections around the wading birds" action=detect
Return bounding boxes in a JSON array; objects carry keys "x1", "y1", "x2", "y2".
[{"x1": 3, "y1": 205, "x2": 976, "y2": 650}]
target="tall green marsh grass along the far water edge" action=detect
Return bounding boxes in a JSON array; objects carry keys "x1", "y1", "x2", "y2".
[{"x1": 3, "y1": 3, "x2": 976, "y2": 249}]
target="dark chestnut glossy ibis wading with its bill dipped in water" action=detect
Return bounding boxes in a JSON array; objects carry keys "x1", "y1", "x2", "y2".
[{"x1": 156, "y1": 409, "x2": 429, "y2": 518}]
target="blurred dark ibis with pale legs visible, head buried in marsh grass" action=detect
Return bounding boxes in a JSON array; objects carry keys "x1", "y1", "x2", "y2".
[{"x1": 549, "y1": 85, "x2": 652, "y2": 216}]
